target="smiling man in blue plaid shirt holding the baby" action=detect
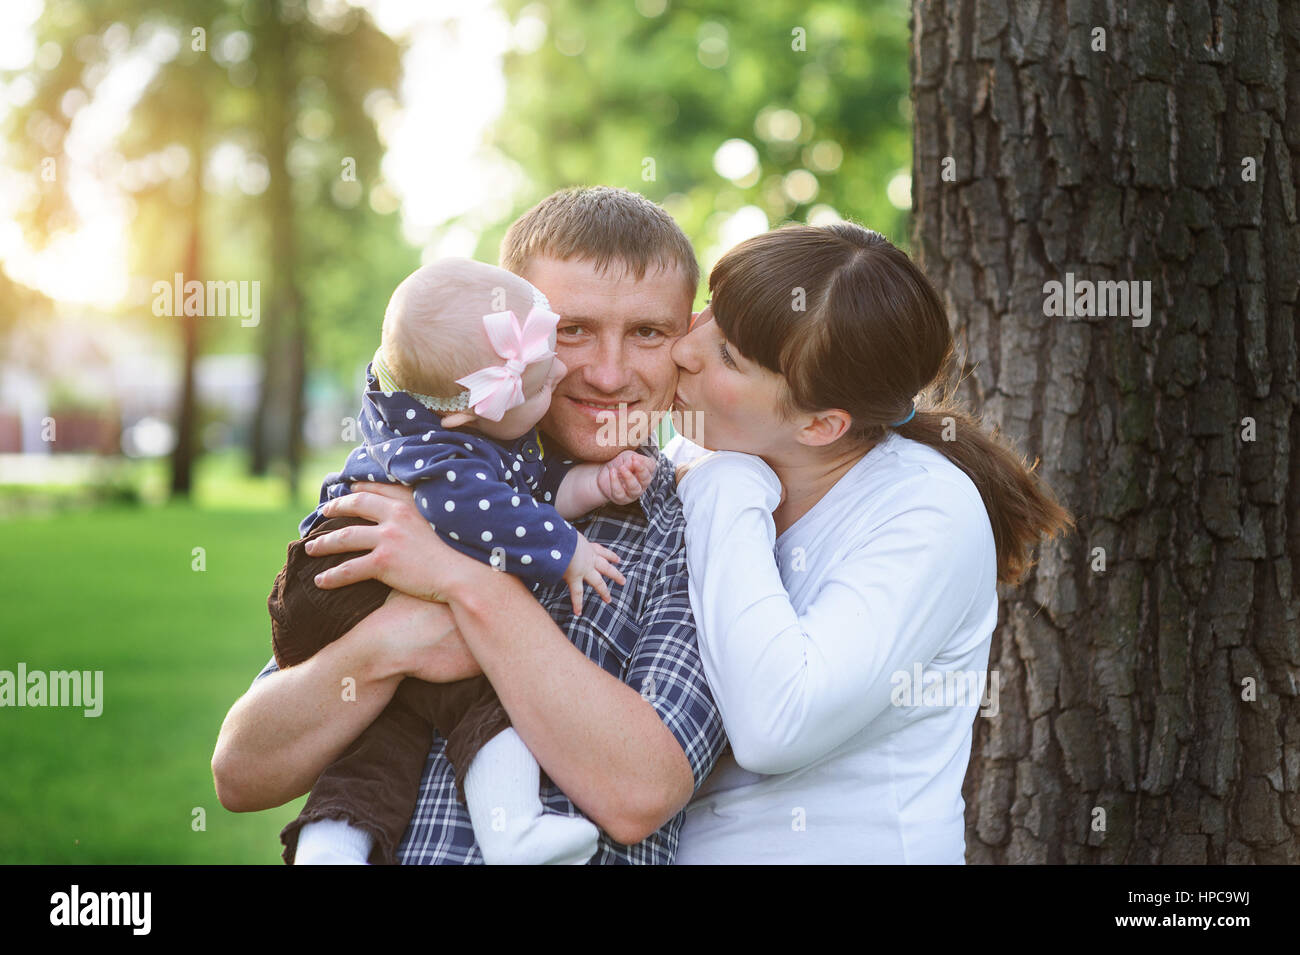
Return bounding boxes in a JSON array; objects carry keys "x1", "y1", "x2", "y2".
[{"x1": 212, "y1": 187, "x2": 725, "y2": 864}]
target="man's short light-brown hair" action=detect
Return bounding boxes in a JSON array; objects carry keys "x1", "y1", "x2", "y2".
[{"x1": 501, "y1": 186, "x2": 699, "y2": 291}]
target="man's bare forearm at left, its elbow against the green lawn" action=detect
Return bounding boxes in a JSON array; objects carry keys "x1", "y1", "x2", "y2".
[{"x1": 212, "y1": 592, "x2": 480, "y2": 812}]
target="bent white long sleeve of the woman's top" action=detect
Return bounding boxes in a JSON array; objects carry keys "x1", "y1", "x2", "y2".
[{"x1": 677, "y1": 452, "x2": 992, "y2": 774}]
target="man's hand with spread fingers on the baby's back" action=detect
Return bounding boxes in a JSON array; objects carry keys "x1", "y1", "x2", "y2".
[{"x1": 307, "y1": 482, "x2": 482, "y2": 600}]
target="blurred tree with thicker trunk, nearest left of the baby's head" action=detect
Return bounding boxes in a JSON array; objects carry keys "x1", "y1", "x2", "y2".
[{"x1": 246, "y1": 0, "x2": 415, "y2": 494}]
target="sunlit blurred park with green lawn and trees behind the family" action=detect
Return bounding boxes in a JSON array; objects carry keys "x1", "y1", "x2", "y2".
[{"x1": 0, "y1": 0, "x2": 910, "y2": 863}]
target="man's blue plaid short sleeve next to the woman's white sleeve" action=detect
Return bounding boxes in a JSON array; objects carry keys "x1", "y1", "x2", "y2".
[{"x1": 625, "y1": 550, "x2": 727, "y2": 789}]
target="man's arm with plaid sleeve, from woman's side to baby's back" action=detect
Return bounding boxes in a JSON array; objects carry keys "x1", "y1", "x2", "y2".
[{"x1": 292, "y1": 485, "x2": 724, "y2": 845}]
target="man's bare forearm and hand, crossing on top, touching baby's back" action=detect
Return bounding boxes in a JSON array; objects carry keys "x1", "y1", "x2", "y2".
[{"x1": 304, "y1": 485, "x2": 694, "y2": 845}]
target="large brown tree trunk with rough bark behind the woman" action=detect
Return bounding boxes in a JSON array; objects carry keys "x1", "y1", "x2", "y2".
[{"x1": 913, "y1": 0, "x2": 1300, "y2": 863}]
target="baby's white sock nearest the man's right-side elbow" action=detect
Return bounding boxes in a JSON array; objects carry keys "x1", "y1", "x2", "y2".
[{"x1": 465, "y1": 729, "x2": 601, "y2": 865}]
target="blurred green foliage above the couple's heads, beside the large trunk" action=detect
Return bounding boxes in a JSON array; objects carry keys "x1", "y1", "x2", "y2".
[{"x1": 477, "y1": 0, "x2": 911, "y2": 283}]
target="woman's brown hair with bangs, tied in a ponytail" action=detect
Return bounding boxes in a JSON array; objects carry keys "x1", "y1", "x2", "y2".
[{"x1": 709, "y1": 222, "x2": 1073, "y2": 583}]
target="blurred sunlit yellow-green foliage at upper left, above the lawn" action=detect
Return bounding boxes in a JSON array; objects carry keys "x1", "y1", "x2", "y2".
[{"x1": 0, "y1": 0, "x2": 419, "y2": 418}]
